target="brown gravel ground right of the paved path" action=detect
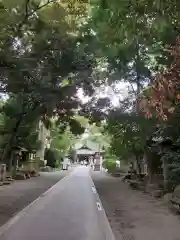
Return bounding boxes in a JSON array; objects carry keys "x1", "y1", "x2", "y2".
[{"x1": 92, "y1": 172, "x2": 180, "y2": 240}]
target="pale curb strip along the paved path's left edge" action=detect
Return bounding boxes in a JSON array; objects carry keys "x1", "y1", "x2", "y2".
[{"x1": 0, "y1": 169, "x2": 74, "y2": 237}]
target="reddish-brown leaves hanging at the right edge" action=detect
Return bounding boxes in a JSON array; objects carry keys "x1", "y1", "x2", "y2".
[{"x1": 138, "y1": 38, "x2": 180, "y2": 120}]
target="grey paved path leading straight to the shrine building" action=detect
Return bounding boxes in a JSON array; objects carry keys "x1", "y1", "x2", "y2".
[{"x1": 0, "y1": 167, "x2": 114, "y2": 240}]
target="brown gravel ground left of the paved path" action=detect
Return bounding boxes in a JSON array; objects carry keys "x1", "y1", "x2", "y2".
[{"x1": 0, "y1": 171, "x2": 67, "y2": 226}]
